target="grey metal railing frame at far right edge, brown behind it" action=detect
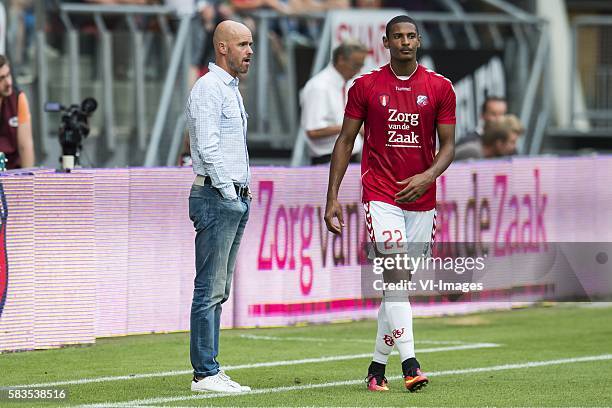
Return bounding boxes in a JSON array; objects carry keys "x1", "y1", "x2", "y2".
[{"x1": 568, "y1": 15, "x2": 612, "y2": 133}]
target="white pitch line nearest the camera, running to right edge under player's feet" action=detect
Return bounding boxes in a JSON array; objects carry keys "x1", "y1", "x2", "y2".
[{"x1": 79, "y1": 354, "x2": 612, "y2": 408}]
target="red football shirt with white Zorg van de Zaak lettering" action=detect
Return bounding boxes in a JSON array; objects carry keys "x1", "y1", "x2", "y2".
[{"x1": 345, "y1": 64, "x2": 456, "y2": 211}]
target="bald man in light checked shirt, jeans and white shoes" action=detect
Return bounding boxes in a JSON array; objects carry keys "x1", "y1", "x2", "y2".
[{"x1": 185, "y1": 21, "x2": 253, "y2": 393}]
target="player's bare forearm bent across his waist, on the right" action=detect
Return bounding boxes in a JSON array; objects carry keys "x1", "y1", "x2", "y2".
[{"x1": 395, "y1": 124, "x2": 455, "y2": 203}]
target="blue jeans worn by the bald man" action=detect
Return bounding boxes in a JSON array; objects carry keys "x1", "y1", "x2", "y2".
[{"x1": 189, "y1": 185, "x2": 251, "y2": 377}]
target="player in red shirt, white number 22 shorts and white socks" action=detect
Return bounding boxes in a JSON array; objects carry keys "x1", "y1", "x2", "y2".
[{"x1": 325, "y1": 15, "x2": 456, "y2": 391}]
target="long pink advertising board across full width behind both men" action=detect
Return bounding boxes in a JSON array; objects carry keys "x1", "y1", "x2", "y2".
[{"x1": 0, "y1": 156, "x2": 612, "y2": 351}]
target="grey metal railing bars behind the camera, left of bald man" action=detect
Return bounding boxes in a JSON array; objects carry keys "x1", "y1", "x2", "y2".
[{"x1": 36, "y1": 3, "x2": 191, "y2": 164}]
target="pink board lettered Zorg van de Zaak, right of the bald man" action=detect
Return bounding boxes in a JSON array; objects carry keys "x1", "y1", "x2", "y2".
[{"x1": 234, "y1": 157, "x2": 612, "y2": 327}]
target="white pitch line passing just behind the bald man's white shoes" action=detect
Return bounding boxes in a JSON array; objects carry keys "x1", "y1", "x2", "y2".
[{"x1": 7, "y1": 343, "x2": 499, "y2": 388}]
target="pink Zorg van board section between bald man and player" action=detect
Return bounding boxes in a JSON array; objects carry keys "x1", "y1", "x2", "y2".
[{"x1": 234, "y1": 166, "x2": 375, "y2": 326}]
